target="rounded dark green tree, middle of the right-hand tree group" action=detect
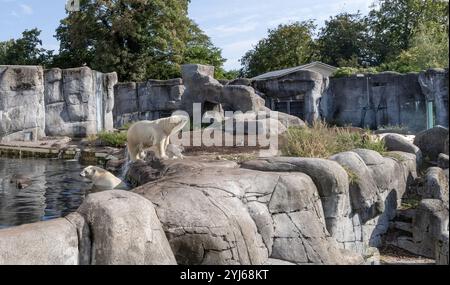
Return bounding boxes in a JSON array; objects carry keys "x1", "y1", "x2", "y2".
[{"x1": 317, "y1": 12, "x2": 368, "y2": 67}]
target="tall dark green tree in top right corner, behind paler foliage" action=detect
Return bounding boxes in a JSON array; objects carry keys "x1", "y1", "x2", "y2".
[{"x1": 368, "y1": 0, "x2": 448, "y2": 65}]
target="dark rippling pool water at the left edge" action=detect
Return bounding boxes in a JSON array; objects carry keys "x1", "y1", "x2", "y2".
[{"x1": 0, "y1": 157, "x2": 92, "y2": 228}]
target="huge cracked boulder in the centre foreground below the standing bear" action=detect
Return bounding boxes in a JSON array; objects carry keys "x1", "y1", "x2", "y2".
[{"x1": 134, "y1": 162, "x2": 362, "y2": 265}]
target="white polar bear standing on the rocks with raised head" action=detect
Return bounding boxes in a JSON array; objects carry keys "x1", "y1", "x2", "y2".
[{"x1": 127, "y1": 115, "x2": 189, "y2": 161}]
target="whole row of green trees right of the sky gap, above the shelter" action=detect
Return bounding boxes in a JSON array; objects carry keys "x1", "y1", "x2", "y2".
[{"x1": 241, "y1": 0, "x2": 449, "y2": 77}]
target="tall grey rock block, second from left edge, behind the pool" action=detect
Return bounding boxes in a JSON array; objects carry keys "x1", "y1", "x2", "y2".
[{"x1": 44, "y1": 67, "x2": 117, "y2": 137}]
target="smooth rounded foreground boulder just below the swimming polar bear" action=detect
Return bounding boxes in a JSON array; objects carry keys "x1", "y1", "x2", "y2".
[{"x1": 78, "y1": 191, "x2": 176, "y2": 265}]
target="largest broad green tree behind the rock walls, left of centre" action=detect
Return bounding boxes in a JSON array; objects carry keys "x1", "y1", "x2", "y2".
[{"x1": 55, "y1": 0, "x2": 227, "y2": 81}]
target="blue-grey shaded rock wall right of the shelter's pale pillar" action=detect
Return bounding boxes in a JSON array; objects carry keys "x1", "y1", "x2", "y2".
[{"x1": 320, "y1": 70, "x2": 448, "y2": 132}]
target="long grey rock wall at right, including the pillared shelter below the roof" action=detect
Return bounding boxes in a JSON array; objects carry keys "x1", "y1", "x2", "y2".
[{"x1": 252, "y1": 69, "x2": 448, "y2": 132}]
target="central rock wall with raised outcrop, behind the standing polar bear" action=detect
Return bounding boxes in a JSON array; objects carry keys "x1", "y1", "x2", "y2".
[{"x1": 114, "y1": 64, "x2": 264, "y2": 127}]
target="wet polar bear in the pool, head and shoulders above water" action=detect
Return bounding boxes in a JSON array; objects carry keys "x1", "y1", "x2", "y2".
[{"x1": 80, "y1": 166, "x2": 129, "y2": 190}]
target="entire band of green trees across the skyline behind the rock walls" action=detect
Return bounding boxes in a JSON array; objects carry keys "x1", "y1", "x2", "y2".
[{"x1": 0, "y1": 0, "x2": 449, "y2": 81}]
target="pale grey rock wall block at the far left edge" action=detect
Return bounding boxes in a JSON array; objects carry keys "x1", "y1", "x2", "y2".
[{"x1": 0, "y1": 66, "x2": 45, "y2": 142}]
